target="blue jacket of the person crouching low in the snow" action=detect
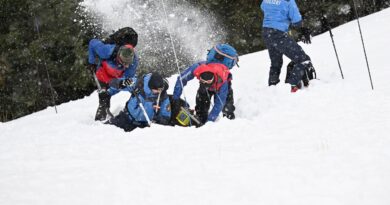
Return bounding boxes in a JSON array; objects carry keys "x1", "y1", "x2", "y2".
[{"x1": 125, "y1": 74, "x2": 171, "y2": 124}]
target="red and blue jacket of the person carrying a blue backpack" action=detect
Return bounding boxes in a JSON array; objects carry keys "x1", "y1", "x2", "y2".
[{"x1": 173, "y1": 62, "x2": 231, "y2": 122}]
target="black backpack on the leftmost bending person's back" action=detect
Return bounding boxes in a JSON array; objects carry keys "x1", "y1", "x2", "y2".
[{"x1": 105, "y1": 27, "x2": 138, "y2": 47}]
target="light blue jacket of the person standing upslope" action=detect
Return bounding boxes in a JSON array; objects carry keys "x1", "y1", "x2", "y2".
[{"x1": 260, "y1": 0, "x2": 302, "y2": 32}]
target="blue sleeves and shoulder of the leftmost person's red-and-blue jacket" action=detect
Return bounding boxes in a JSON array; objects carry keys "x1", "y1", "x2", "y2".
[{"x1": 88, "y1": 39, "x2": 139, "y2": 95}]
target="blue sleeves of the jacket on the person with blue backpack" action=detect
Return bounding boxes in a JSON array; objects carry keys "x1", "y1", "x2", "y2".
[{"x1": 173, "y1": 62, "x2": 229, "y2": 122}]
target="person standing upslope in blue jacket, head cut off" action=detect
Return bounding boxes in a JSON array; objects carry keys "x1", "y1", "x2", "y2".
[{"x1": 261, "y1": 0, "x2": 312, "y2": 92}]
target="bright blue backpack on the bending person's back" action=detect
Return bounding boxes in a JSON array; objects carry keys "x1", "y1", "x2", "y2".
[{"x1": 206, "y1": 44, "x2": 238, "y2": 69}]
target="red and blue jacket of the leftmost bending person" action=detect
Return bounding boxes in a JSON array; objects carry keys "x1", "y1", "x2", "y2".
[{"x1": 88, "y1": 39, "x2": 139, "y2": 95}]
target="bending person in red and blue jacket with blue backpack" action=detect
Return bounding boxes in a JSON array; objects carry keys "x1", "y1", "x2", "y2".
[{"x1": 172, "y1": 44, "x2": 238, "y2": 124}]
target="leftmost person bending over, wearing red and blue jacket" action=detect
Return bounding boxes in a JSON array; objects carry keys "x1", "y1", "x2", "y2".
[{"x1": 88, "y1": 28, "x2": 138, "y2": 121}]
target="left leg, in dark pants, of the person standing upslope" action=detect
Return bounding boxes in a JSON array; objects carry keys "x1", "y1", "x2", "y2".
[{"x1": 263, "y1": 28, "x2": 283, "y2": 86}]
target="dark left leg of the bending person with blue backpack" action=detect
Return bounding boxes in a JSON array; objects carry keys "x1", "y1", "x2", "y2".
[{"x1": 195, "y1": 87, "x2": 211, "y2": 124}]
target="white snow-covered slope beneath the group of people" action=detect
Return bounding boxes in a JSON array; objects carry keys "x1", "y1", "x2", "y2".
[{"x1": 0, "y1": 9, "x2": 390, "y2": 205}]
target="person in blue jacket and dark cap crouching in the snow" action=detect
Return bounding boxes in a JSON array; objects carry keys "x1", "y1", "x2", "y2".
[{"x1": 106, "y1": 73, "x2": 171, "y2": 132}]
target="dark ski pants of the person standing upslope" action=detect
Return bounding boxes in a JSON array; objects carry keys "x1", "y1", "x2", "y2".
[{"x1": 263, "y1": 28, "x2": 310, "y2": 85}]
